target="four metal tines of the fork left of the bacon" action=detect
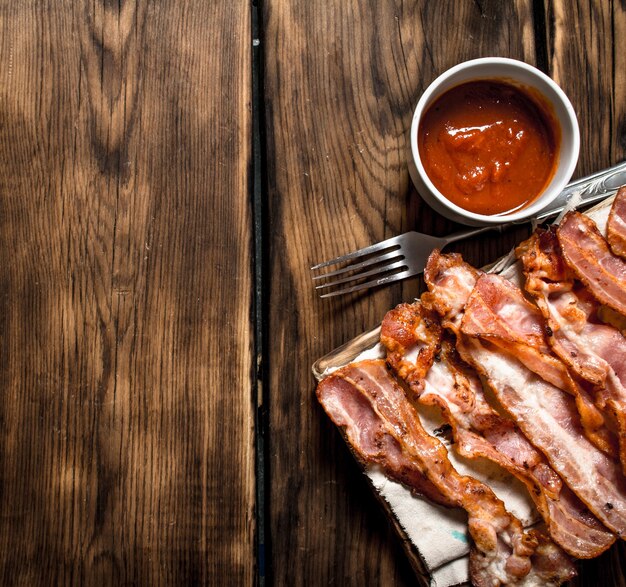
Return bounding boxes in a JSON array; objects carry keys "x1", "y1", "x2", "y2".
[{"x1": 311, "y1": 237, "x2": 408, "y2": 298}]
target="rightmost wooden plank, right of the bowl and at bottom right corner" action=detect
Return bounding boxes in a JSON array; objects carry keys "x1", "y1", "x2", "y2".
[{"x1": 545, "y1": 0, "x2": 626, "y2": 587}]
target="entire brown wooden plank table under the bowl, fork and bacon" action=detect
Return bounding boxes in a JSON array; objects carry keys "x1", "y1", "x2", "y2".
[{"x1": 0, "y1": 0, "x2": 626, "y2": 586}]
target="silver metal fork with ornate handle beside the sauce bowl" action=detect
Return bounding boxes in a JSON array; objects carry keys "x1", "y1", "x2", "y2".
[{"x1": 311, "y1": 162, "x2": 626, "y2": 298}]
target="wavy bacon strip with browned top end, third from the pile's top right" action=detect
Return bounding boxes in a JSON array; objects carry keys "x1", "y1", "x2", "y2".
[{"x1": 516, "y1": 229, "x2": 626, "y2": 472}]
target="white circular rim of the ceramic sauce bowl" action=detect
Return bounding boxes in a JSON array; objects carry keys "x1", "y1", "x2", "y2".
[{"x1": 410, "y1": 57, "x2": 580, "y2": 224}]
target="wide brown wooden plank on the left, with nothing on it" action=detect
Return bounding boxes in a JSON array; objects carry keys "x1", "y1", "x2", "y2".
[{"x1": 0, "y1": 0, "x2": 256, "y2": 585}]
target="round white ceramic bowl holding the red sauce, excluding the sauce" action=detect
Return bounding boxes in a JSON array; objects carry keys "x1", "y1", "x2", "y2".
[{"x1": 409, "y1": 57, "x2": 580, "y2": 226}]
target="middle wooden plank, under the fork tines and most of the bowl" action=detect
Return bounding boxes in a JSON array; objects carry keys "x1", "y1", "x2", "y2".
[{"x1": 262, "y1": 0, "x2": 534, "y2": 585}]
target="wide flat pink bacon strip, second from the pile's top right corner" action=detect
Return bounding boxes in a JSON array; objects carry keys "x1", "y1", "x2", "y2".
[{"x1": 557, "y1": 212, "x2": 626, "y2": 315}]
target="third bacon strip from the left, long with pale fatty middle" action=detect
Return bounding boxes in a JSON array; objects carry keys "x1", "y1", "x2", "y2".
[{"x1": 422, "y1": 251, "x2": 626, "y2": 537}]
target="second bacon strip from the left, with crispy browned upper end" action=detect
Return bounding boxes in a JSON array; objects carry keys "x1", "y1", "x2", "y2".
[{"x1": 381, "y1": 301, "x2": 615, "y2": 558}]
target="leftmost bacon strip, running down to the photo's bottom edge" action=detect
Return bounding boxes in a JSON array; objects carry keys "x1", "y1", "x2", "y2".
[{"x1": 317, "y1": 360, "x2": 575, "y2": 587}]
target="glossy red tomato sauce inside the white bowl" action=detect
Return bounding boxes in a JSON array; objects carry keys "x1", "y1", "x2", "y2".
[{"x1": 418, "y1": 80, "x2": 560, "y2": 215}]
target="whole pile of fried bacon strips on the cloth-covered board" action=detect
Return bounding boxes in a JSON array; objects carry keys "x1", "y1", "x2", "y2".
[{"x1": 317, "y1": 194, "x2": 626, "y2": 586}]
